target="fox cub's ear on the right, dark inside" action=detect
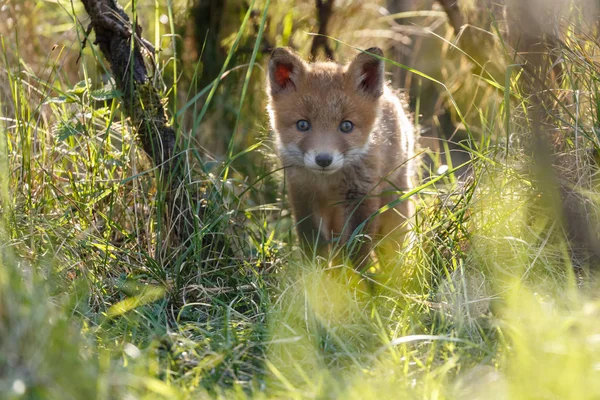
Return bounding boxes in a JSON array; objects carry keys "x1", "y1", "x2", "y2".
[{"x1": 346, "y1": 47, "x2": 384, "y2": 98}]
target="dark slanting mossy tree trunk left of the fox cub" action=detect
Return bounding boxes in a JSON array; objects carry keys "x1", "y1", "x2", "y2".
[{"x1": 81, "y1": 0, "x2": 196, "y2": 258}]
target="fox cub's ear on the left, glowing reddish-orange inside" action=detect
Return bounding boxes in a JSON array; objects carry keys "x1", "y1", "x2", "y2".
[{"x1": 269, "y1": 47, "x2": 305, "y2": 95}]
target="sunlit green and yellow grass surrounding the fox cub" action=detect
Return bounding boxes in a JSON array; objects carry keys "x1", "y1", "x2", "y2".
[{"x1": 0, "y1": 0, "x2": 600, "y2": 399}]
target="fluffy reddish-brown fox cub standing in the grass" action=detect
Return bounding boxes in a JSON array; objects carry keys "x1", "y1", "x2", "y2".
[{"x1": 267, "y1": 48, "x2": 415, "y2": 268}]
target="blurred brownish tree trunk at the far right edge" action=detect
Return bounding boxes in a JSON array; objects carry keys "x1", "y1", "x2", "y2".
[{"x1": 506, "y1": 0, "x2": 600, "y2": 268}]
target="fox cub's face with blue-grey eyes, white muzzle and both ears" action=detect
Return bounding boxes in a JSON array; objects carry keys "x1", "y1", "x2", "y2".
[{"x1": 268, "y1": 48, "x2": 384, "y2": 175}]
